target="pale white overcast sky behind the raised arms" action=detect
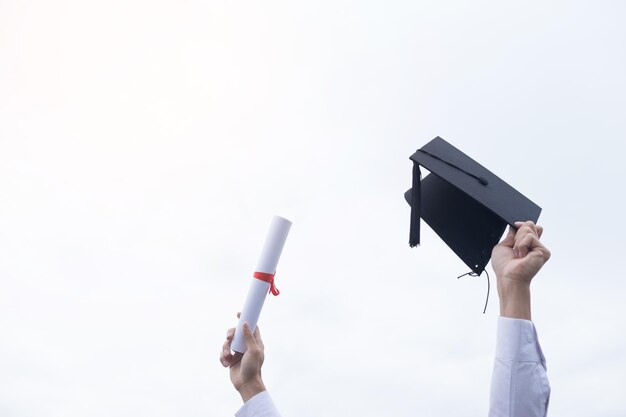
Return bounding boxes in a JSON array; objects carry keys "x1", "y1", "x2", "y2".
[{"x1": 0, "y1": 0, "x2": 626, "y2": 417}]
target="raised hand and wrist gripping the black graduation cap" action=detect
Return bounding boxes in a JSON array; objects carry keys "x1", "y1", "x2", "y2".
[{"x1": 491, "y1": 221, "x2": 550, "y2": 320}]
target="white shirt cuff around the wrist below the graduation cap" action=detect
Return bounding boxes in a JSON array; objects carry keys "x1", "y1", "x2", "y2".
[{"x1": 496, "y1": 317, "x2": 545, "y2": 364}]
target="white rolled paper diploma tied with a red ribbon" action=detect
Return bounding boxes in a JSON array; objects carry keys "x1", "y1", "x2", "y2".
[{"x1": 231, "y1": 216, "x2": 291, "y2": 353}]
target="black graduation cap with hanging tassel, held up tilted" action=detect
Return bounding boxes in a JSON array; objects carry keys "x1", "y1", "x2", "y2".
[{"x1": 404, "y1": 137, "x2": 541, "y2": 275}]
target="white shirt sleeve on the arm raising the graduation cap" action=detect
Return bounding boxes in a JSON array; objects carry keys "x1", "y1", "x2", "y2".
[{"x1": 489, "y1": 317, "x2": 550, "y2": 417}]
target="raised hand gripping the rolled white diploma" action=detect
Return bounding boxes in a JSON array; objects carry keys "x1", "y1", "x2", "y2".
[{"x1": 220, "y1": 313, "x2": 265, "y2": 403}]
